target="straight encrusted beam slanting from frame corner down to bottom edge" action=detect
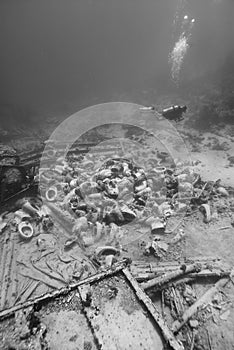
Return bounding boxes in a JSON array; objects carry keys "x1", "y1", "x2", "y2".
[{"x1": 123, "y1": 268, "x2": 184, "y2": 350}]
